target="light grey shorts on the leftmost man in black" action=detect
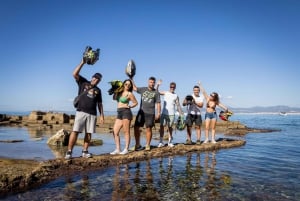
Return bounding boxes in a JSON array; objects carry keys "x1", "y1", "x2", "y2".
[{"x1": 73, "y1": 111, "x2": 97, "y2": 133}]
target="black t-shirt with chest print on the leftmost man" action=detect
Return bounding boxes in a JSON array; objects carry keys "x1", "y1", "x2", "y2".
[{"x1": 76, "y1": 76, "x2": 102, "y2": 115}]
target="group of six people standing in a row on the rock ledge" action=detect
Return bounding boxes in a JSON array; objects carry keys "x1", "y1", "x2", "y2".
[{"x1": 65, "y1": 59, "x2": 232, "y2": 159}]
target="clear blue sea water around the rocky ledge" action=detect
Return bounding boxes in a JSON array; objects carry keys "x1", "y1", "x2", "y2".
[{"x1": 0, "y1": 114, "x2": 300, "y2": 201}]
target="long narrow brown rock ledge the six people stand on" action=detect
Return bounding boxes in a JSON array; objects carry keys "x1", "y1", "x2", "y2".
[{"x1": 0, "y1": 138, "x2": 246, "y2": 198}]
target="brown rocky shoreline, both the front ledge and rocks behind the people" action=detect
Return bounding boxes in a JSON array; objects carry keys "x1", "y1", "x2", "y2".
[{"x1": 0, "y1": 111, "x2": 274, "y2": 196}]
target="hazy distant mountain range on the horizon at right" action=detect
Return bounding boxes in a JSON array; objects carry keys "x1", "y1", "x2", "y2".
[{"x1": 232, "y1": 105, "x2": 300, "y2": 113}]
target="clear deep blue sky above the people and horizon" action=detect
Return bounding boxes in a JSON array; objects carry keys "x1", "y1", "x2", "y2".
[{"x1": 0, "y1": 0, "x2": 300, "y2": 111}]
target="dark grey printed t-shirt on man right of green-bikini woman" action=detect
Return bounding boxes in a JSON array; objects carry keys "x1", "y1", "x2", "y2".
[{"x1": 137, "y1": 87, "x2": 160, "y2": 114}]
